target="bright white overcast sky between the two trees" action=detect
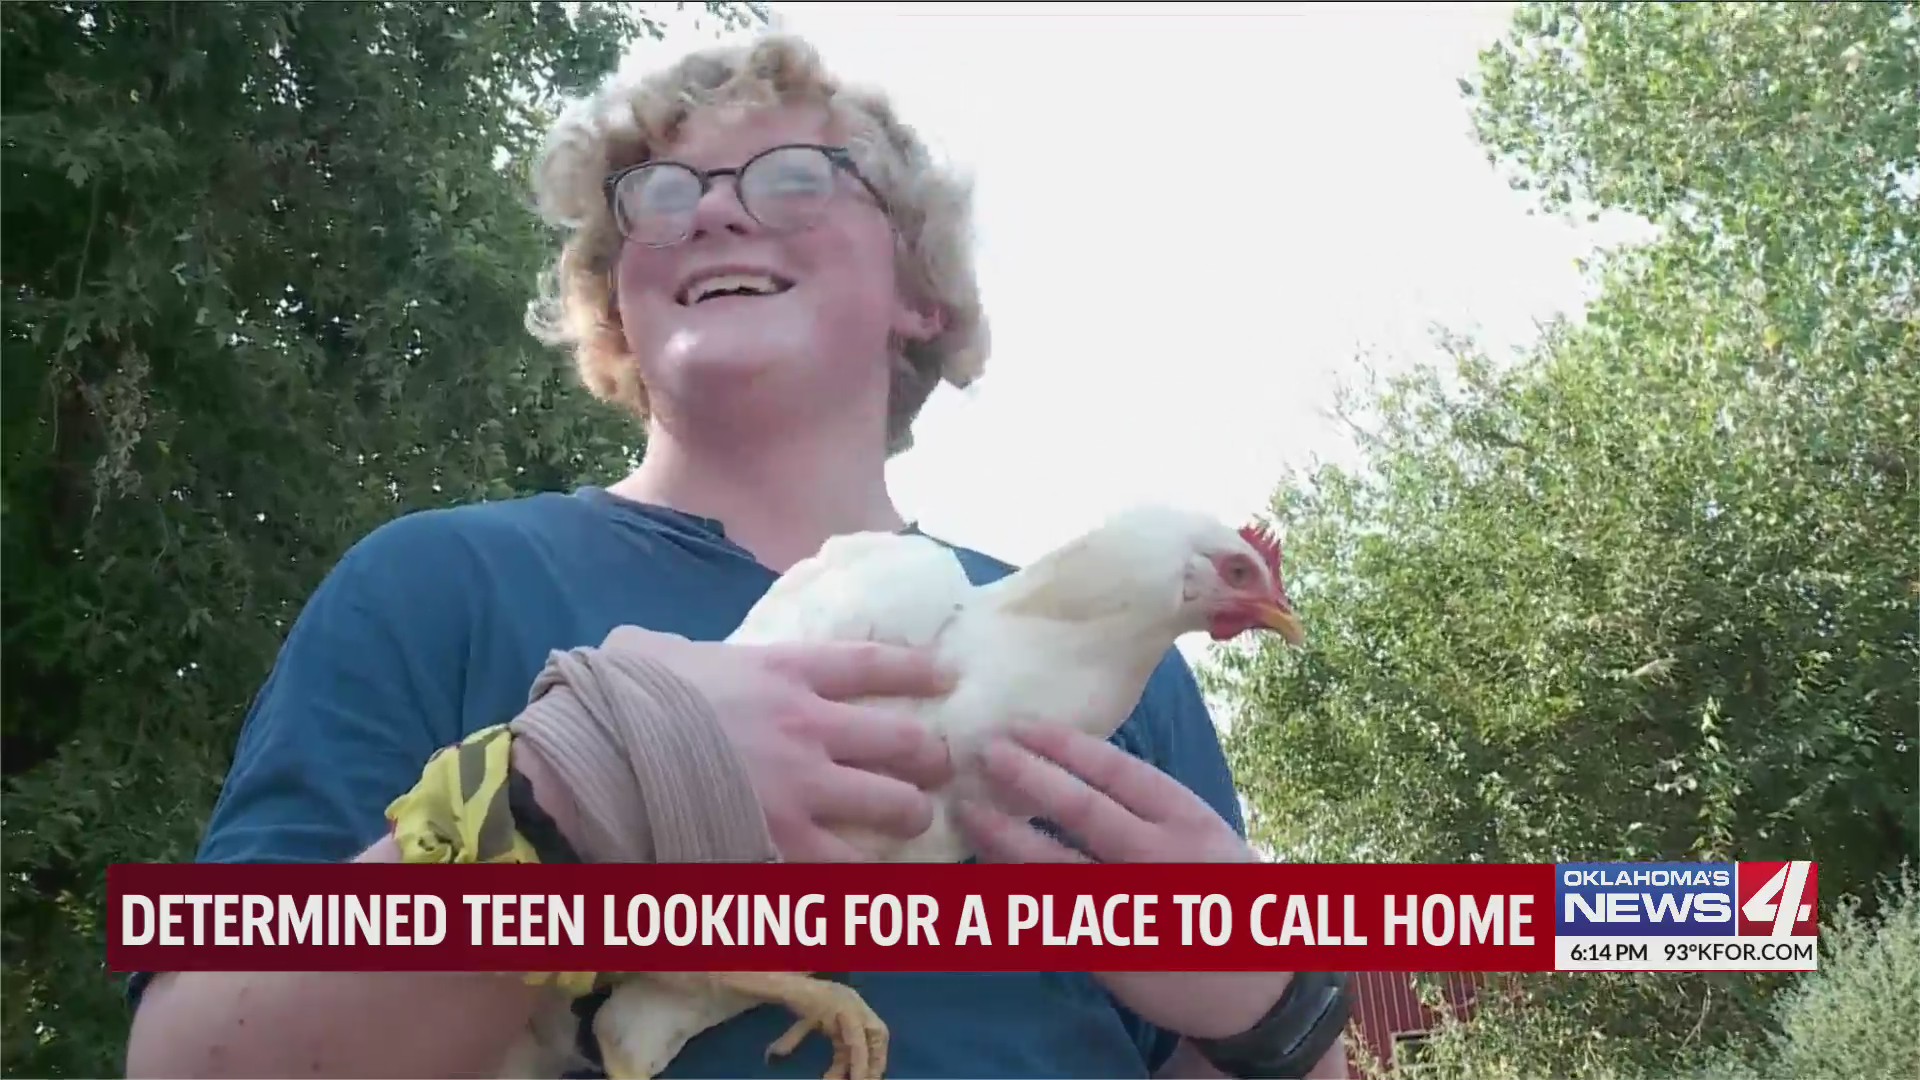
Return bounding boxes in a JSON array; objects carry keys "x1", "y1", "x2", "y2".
[{"x1": 629, "y1": 2, "x2": 1651, "y2": 657}]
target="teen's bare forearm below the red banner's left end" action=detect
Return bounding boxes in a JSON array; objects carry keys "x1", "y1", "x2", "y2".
[{"x1": 127, "y1": 838, "x2": 553, "y2": 1078}]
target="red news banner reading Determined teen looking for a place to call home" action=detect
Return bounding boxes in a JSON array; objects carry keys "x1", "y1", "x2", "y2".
[{"x1": 108, "y1": 863, "x2": 1818, "y2": 972}]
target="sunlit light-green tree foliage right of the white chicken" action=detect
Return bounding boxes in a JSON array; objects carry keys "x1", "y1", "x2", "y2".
[{"x1": 1208, "y1": 4, "x2": 1920, "y2": 1070}]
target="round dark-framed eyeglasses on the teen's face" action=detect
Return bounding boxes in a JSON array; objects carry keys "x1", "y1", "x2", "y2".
[{"x1": 607, "y1": 142, "x2": 887, "y2": 248}]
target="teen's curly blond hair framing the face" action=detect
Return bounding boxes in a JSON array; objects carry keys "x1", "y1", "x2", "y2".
[{"x1": 526, "y1": 35, "x2": 987, "y2": 454}]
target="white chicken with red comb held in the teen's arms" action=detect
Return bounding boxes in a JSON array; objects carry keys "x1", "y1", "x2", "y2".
[{"x1": 503, "y1": 505, "x2": 1302, "y2": 1080}]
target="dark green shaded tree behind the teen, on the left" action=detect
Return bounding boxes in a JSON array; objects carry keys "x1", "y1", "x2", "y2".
[{"x1": 0, "y1": 2, "x2": 758, "y2": 1076}]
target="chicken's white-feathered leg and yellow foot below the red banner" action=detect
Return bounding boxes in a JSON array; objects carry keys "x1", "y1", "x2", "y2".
[{"x1": 593, "y1": 970, "x2": 887, "y2": 1080}]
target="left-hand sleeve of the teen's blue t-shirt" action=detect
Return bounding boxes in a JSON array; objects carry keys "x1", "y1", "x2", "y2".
[{"x1": 127, "y1": 511, "x2": 476, "y2": 1005}]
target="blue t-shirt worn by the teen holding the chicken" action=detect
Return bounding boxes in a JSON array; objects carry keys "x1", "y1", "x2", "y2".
[{"x1": 131, "y1": 488, "x2": 1244, "y2": 1078}]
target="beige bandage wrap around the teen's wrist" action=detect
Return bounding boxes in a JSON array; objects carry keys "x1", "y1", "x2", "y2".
[{"x1": 513, "y1": 648, "x2": 780, "y2": 863}]
